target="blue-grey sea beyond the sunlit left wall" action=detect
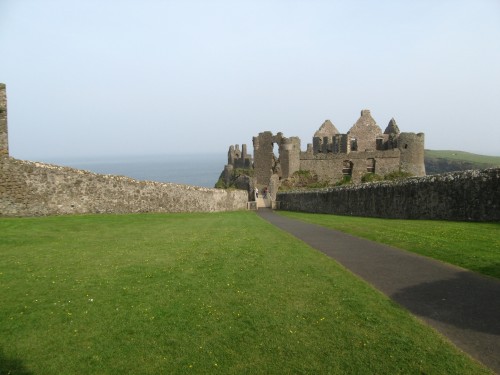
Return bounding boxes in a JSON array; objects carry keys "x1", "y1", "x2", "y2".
[{"x1": 44, "y1": 154, "x2": 227, "y2": 188}]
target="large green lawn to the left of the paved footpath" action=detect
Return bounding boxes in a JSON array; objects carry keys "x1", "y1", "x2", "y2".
[{"x1": 0, "y1": 212, "x2": 489, "y2": 374}]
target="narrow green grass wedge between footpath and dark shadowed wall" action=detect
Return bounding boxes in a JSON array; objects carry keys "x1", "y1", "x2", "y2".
[{"x1": 280, "y1": 211, "x2": 500, "y2": 278}]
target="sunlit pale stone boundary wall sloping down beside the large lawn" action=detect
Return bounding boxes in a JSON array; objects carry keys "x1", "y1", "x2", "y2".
[{"x1": 0, "y1": 156, "x2": 248, "y2": 216}]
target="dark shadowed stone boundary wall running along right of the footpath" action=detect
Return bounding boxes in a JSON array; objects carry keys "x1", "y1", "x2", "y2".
[{"x1": 277, "y1": 168, "x2": 500, "y2": 221}]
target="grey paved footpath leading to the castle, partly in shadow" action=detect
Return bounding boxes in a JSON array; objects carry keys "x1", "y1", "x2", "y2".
[{"x1": 258, "y1": 209, "x2": 500, "y2": 374}]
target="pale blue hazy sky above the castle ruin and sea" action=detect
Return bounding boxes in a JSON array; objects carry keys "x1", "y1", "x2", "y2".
[{"x1": 0, "y1": 0, "x2": 500, "y2": 160}]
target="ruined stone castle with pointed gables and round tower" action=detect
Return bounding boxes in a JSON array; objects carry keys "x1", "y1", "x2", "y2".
[{"x1": 224, "y1": 109, "x2": 425, "y2": 192}]
